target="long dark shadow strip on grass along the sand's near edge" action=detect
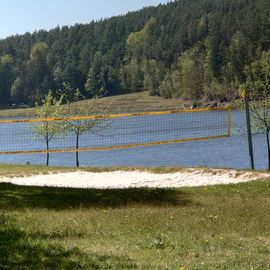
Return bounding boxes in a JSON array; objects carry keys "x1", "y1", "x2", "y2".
[{"x1": 0, "y1": 184, "x2": 191, "y2": 209}]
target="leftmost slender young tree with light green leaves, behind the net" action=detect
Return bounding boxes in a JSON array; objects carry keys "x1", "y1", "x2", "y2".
[{"x1": 30, "y1": 90, "x2": 63, "y2": 166}]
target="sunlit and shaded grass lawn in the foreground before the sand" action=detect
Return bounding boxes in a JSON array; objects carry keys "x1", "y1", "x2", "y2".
[{"x1": 0, "y1": 166, "x2": 270, "y2": 270}]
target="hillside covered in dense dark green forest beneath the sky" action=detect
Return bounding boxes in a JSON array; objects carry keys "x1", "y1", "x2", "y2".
[{"x1": 0, "y1": 0, "x2": 270, "y2": 106}]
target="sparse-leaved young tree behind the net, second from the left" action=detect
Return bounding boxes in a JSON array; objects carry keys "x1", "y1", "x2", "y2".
[{"x1": 65, "y1": 103, "x2": 110, "y2": 167}]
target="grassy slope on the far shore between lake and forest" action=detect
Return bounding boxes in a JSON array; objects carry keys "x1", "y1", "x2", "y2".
[{"x1": 0, "y1": 92, "x2": 192, "y2": 117}]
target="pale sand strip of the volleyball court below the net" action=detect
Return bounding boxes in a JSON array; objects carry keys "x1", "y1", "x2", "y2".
[{"x1": 0, "y1": 168, "x2": 270, "y2": 189}]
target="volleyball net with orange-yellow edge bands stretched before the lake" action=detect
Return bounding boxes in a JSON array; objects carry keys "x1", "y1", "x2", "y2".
[{"x1": 0, "y1": 107, "x2": 231, "y2": 155}]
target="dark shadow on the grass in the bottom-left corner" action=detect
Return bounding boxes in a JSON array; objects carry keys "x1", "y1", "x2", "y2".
[{"x1": 0, "y1": 215, "x2": 137, "y2": 270}]
